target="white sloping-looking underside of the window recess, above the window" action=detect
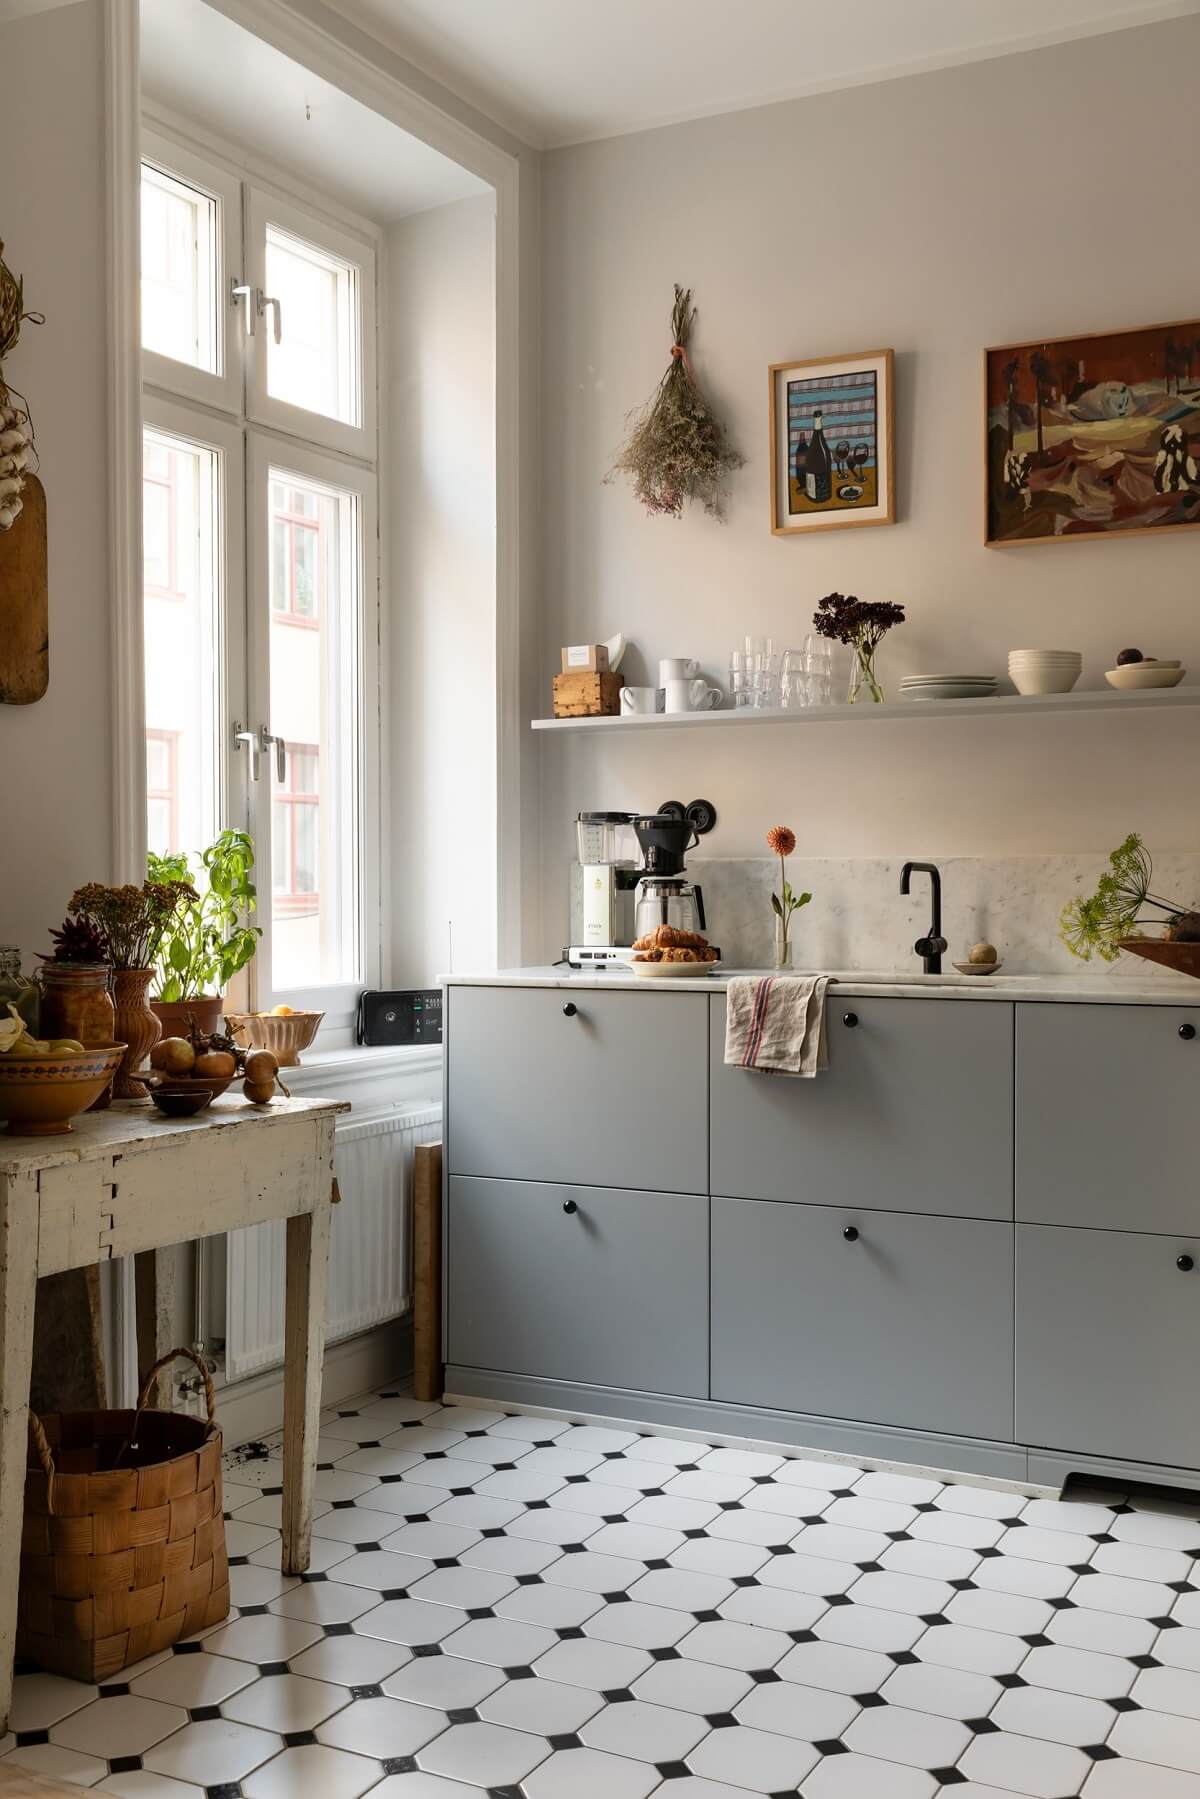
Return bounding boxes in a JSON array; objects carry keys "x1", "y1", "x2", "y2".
[{"x1": 140, "y1": 0, "x2": 491, "y2": 225}]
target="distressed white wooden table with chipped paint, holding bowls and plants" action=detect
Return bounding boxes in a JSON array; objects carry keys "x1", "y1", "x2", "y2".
[{"x1": 0, "y1": 1097, "x2": 349, "y2": 1732}]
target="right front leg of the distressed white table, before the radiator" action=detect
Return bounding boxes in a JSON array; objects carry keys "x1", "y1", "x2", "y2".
[{"x1": 282, "y1": 1193, "x2": 331, "y2": 1574}]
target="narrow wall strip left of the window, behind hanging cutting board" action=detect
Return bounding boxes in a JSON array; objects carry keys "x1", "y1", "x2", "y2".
[{"x1": 0, "y1": 0, "x2": 112, "y2": 962}]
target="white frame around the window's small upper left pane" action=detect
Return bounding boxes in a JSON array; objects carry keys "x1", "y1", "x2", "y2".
[{"x1": 142, "y1": 130, "x2": 246, "y2": 412}]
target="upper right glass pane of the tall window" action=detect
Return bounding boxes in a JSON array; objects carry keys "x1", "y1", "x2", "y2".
[{"x1": 266, "y1": 225, "x2": 362, "y2": 425}]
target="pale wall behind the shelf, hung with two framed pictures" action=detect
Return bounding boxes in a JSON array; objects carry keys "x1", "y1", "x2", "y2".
[{"x1": 531, "y1": 18, "x2": 1200, "y2": 950}]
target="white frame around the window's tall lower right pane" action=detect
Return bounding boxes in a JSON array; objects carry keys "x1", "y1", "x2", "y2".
[{"x1": 246, "y1": 428, "x2": 383, "y2": 1042}]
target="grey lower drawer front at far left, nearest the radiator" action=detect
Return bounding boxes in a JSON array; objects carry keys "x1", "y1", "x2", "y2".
[{"x1": 446, "y1": 1177, "x2": 709, "y2": 1400}]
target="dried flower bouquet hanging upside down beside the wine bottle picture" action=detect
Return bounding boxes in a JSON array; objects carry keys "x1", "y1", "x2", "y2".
[{"x1": 604, "y1": 282, "x2": 745, "y2": 518}]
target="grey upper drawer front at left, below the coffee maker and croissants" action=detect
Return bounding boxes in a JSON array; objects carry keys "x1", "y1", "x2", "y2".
[{"x1": 446, "y1": 988, "x2": 709, "y2": 1193}]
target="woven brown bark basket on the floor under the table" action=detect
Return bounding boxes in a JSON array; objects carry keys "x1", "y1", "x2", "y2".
[{"x1": 16, "y1": 1349, "x2": 228, "y2": 1682}]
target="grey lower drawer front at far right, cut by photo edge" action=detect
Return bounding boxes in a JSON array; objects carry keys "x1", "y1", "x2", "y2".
[{"x1": 1016, "y1": 1225, "x2": 1200, "y2": 1468}]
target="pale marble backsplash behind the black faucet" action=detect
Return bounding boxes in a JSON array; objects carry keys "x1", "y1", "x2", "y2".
[{"x1": 570, "y1": 853, "x2": 1200, "y2": 980}]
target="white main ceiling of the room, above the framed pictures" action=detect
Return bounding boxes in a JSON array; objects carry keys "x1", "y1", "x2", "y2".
[{"x1": 318, "y1": 0, "x2": 1200, "y2": 148}]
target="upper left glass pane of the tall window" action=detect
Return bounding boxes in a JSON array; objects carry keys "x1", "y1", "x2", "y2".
[{"x1": 142, "y1": 162, "x2": 219, "y2": 374}]
